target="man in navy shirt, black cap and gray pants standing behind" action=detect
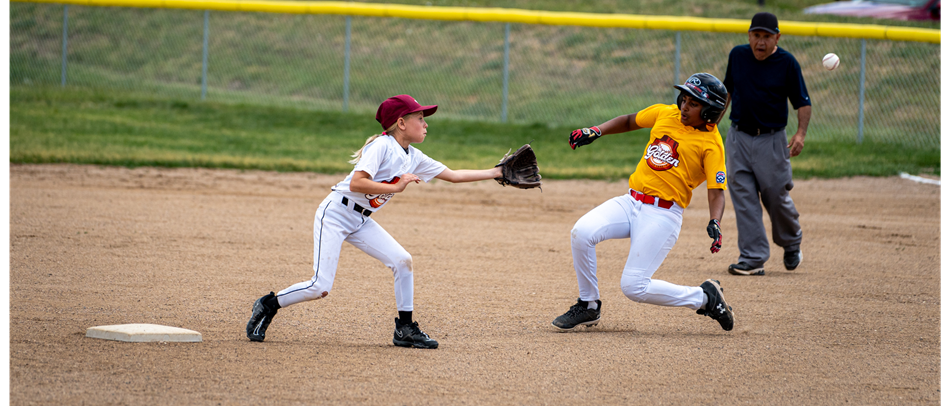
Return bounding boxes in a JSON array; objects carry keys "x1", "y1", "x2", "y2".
[{"x1": 723, "y1": 12, "x2": 811, "y2": 275}]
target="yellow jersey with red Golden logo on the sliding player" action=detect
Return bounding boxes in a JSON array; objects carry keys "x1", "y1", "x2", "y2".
[{"x1": 628, "y1": 104, "x2": 726, "y2": 208}]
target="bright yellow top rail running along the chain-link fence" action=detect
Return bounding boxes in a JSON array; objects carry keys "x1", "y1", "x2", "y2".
[{"x1": 10, "y1": 0, "x2": 942, "y2": 44}]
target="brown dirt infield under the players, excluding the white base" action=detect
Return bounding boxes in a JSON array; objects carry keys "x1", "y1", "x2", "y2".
[{"x1": 9, "y1": 165, "x2": 942, "y2": 405}]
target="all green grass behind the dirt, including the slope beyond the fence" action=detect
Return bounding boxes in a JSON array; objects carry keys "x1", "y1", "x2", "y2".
[{"x1": 8, "y1": 0, "x2": 942, "y2": 179}]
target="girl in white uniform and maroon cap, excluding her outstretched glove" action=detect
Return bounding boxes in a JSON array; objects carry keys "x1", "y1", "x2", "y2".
[{"x1": 246, "y1": 95, "x2": 501, "y2": 348}]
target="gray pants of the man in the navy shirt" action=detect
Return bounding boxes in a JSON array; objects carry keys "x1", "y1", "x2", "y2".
[{"x1": 726, "y1": 124, "x2": 801, "y2": 267}]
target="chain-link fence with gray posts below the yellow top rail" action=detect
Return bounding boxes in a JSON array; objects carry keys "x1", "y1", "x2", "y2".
[{"x1": 9, "y1": 3, "x2": 942, "y2": 149}]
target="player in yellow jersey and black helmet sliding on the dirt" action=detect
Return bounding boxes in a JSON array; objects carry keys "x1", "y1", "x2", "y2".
[{"x1": 553, "y1": 73, "x2": 734, "y2": 331}]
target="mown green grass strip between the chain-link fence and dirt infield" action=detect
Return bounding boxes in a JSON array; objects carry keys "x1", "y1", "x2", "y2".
[{"x1": 9, "y1": 86, "x2": 942, "y2": 179}]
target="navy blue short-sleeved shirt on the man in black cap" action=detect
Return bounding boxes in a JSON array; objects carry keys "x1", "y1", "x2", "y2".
[{"x1": 723, "y1": 44, "x2": 811, "y2": 128}]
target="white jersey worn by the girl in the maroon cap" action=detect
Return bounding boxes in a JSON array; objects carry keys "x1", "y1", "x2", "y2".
[{"x1": 330, "y1": 135, "x2": 447, "y2": 212}]
